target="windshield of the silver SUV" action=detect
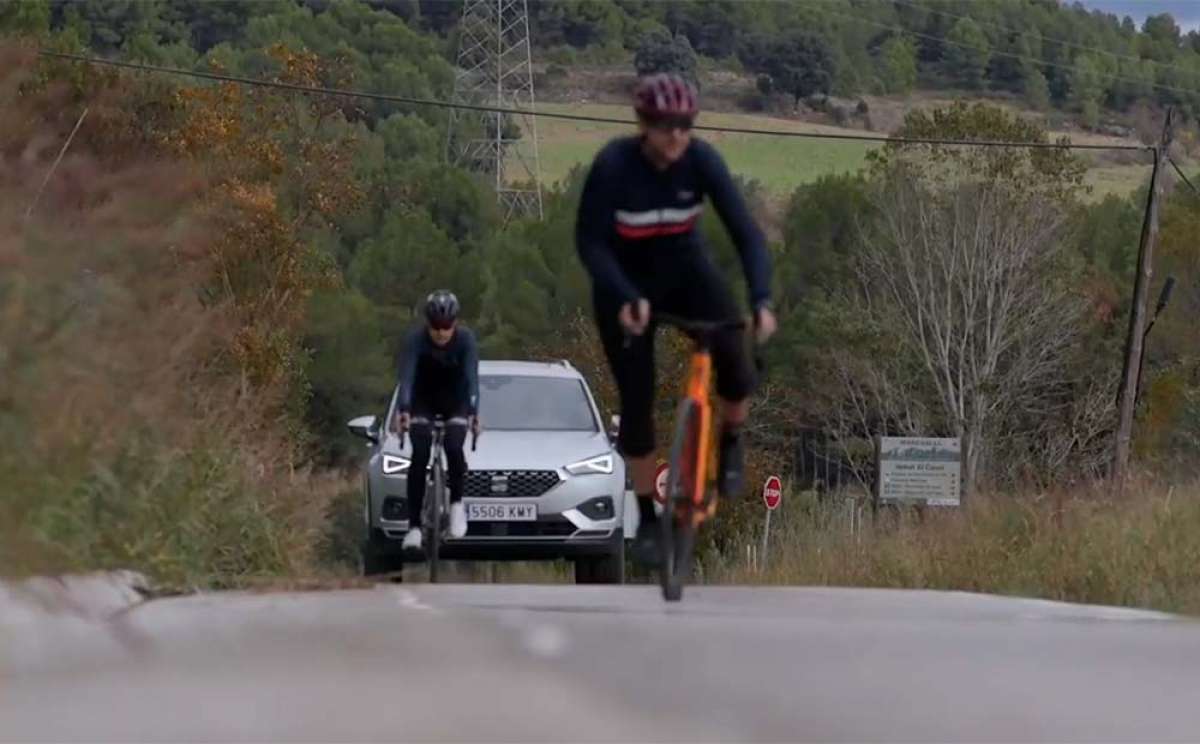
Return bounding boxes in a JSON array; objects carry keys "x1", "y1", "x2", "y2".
[{"x1": 479, "y1": 374, "x2": 596, "y2": 432}]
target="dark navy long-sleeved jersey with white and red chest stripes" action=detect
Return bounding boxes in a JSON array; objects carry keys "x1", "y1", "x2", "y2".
[{"x1": 575, "y1": 137, "x2": 770, "y2": 305}]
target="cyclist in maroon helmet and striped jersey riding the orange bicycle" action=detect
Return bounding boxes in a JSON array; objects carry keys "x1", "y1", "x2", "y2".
[{"x1": 575, "y1": 73, "x2": 776, "y2": 563}]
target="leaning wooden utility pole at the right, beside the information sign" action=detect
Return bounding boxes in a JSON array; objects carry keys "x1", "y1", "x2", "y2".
[{"x1": 1112, "y1": 108, "x2": 1175, "y2": 484}]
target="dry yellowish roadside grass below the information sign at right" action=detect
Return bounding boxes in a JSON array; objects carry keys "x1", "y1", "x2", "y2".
[{"x1": 709, "y1": 484, "x2": 1200, "y2": 613}]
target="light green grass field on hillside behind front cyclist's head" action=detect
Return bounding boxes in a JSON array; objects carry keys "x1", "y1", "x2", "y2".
[{"x1": 523, "y1": 103, "x2": 1150, "y2": 199}]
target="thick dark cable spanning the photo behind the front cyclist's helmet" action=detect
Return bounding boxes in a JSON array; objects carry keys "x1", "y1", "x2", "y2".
[{"x1": 38, "y1": 50, "x2": 1151, "y2": 151}]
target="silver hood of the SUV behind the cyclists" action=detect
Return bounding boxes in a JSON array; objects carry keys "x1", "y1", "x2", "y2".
[{"x1": 384, "y1": 428, "x2": 620, "y2": 470}]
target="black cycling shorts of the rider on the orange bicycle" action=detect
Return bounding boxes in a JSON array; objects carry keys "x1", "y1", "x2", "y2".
[{"x1": 593, "y1": 257, "x2": 756, "y2": 457}]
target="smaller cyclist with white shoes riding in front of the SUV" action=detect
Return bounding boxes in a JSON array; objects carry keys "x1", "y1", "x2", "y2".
[{"x1": 394, "y1": 289, "x2": 479, "y2": 551}]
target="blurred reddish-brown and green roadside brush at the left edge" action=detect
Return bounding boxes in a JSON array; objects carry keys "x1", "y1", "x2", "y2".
[{"x1": 0, "y1": 47, "x2": 340, "y2": 586}]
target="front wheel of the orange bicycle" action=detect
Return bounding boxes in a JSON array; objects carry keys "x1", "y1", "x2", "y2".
[{"x1": 659, "y1": 398, "x2": 700, "y2": 601}]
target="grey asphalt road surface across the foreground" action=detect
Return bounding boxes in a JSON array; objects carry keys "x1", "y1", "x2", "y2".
[{"x1": 0, "y1": 584, "x2": 1200, "y2": 742}]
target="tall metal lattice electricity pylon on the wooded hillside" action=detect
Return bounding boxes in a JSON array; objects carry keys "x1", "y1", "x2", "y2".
[{"x1": 446, "y1": 0, "x2": 542, "y2": 222}]
